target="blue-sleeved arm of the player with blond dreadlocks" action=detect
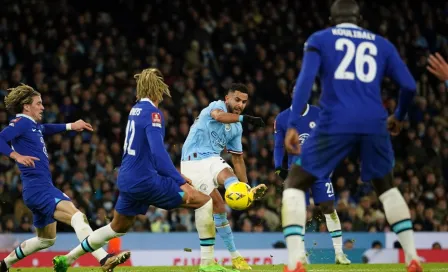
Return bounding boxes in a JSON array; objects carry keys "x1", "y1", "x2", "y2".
[{"x1": 145, "y1": 124, "x2": 186, "y2": 185}]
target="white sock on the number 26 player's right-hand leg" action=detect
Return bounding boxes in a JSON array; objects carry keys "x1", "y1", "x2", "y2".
[{"x1": 379, "y1": 188, "x2": 418, "y2": 264}]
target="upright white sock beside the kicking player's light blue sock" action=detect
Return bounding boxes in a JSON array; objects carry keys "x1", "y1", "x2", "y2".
[{"x1": 194, "y1": 199, "x2": 216, "y2": 265}]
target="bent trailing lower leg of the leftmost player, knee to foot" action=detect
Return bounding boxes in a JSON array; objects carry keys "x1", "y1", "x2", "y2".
[{"x1": 0, "y1": 221, "x2": 56, "y2": 272}]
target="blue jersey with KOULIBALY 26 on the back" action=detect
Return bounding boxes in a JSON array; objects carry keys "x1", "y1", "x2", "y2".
[{"x1": 290, "y1": 23, "x2": 415, "y2": 134}]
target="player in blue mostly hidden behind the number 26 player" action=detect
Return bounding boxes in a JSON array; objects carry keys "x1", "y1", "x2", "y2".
[{"x1": 274, "y1": 81, "x2": 351, "y2": 264}]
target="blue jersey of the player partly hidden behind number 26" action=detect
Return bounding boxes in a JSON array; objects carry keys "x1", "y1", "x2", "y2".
[{"x1": 274, "y1": 104, "x2": 320, "y2": 169}]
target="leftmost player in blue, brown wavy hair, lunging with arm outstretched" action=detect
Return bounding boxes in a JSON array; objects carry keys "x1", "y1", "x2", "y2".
[{"x1": 0, "y1": 84, "x2": 129, "y2": 272}]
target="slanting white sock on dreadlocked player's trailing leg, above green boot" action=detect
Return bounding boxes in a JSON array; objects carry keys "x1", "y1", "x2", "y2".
[{"x1": 66, "y1": 224, "x2": 124, "y2": 264}]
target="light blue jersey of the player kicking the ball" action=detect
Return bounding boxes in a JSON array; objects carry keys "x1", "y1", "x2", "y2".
[{"x1": 182, "y1": 100, "x2": 243, "y2": 161}]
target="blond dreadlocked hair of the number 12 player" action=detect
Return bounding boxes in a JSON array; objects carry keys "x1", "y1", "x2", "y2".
[{"x1": 134, "y1": 68, "x2": 171, "y2": 102}]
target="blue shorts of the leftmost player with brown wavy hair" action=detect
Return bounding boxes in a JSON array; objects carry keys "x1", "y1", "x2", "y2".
[{"x1": 23, "y1": 181, "x2": 71, "y2": 229}]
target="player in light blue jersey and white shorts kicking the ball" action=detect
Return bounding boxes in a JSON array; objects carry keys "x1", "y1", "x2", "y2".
[{"x1": 180, "y1": 84, "x2": 267, "y2": 270}]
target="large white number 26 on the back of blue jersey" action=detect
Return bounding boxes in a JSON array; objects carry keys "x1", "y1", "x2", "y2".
[{"x1": 334, "y1": 38, "x2": 378, "y2": 83}]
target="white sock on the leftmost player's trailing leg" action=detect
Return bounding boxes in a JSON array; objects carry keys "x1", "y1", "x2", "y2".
[{"x1": 4, "y1": 237, "x2": 56, "y2": 268}]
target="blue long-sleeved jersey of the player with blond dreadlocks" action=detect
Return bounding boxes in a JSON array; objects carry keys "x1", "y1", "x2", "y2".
[{"x1": 117, "y1": 98, "x2": 185, "y2": 193}]
